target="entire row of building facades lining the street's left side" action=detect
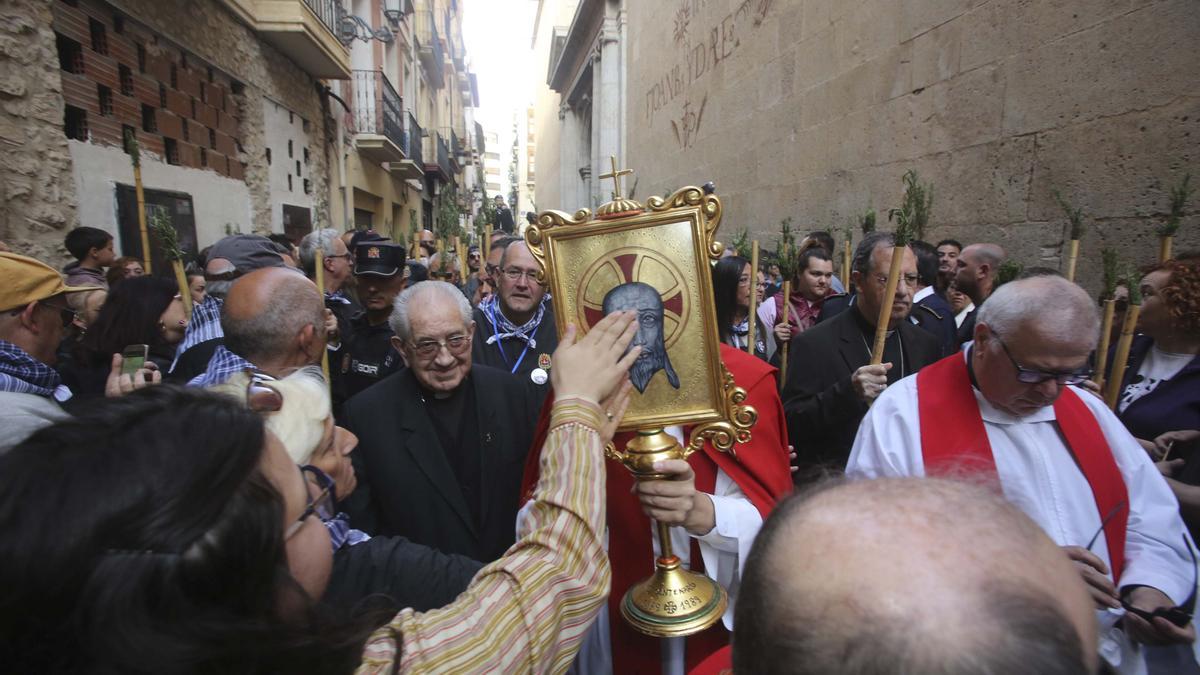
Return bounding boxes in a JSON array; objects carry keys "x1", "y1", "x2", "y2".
[{"x1": 0, "y1": 0, "x2": 487, "y2": 262}]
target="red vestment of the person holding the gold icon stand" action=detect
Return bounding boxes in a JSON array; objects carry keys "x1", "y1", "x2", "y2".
[{"x1": 522, "y1": 345, "x2": 792, "y2": 675}]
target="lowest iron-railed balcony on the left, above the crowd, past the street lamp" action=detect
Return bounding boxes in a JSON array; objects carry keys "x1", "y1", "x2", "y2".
[{"x1": 354, "y1": 70, "x2": 410, "y2": 163}]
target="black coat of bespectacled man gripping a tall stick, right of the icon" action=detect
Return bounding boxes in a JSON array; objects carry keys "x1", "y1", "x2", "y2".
[{"x1": 781, "y1": 309, "x2": 941, "y2": 482}]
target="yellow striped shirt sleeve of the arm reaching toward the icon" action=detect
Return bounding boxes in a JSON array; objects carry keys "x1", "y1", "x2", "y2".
[{"x1": 358, "y1": 399, "x2": 611, "y2": 675}]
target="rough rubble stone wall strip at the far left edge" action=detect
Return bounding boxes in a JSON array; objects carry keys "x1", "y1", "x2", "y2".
[{"x1": 0, "y1": 0, "x2": 79, "y2": 261}]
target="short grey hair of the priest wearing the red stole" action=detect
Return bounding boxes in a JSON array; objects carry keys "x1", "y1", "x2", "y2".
[{"x1": 976, "y1": 276, "x2": 1100, "y2": 350}]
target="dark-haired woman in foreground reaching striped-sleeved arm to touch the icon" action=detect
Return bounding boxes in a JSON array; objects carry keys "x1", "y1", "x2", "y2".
[{"x1": 0, "y1": 315, "x2": 638, "y2": 673}]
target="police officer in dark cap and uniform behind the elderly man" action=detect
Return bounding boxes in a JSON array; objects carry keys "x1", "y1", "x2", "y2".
[{"x1": 340, "y1": 241, "x2": 408, "y2": 398}]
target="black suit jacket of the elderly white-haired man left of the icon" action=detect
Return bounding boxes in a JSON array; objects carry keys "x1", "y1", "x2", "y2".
[{"x1": 343, "y1": 365, "x2": 540, "y2": 562}]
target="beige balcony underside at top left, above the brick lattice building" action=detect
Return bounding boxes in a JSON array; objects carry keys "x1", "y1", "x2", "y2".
[{"x1": 222, "y1": 0, "x2": 350, "y2": 79}]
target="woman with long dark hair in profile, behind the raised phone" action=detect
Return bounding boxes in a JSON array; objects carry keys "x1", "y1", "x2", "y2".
[{"x1": 62, "y1": 276, "x2": 187, "y2": 400}]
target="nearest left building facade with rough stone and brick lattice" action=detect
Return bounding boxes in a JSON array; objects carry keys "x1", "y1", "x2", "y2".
[{"x1": 0, "y1": 0, "x2": 349, "y2": 261}]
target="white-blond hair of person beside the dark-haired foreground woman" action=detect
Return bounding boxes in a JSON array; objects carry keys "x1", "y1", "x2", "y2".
[{"x1": 211, "y1": 366, "x2": 332, "y2": 465}]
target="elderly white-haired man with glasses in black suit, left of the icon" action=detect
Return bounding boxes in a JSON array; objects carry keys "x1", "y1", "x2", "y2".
[{"x1": 342, "y1": 280, "x2": 540, "y2": 562}]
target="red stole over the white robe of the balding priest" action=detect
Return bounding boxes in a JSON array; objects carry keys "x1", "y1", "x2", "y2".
[{"x1": 917, "y1": 353, "x2": 1129, "y2": 583}]
